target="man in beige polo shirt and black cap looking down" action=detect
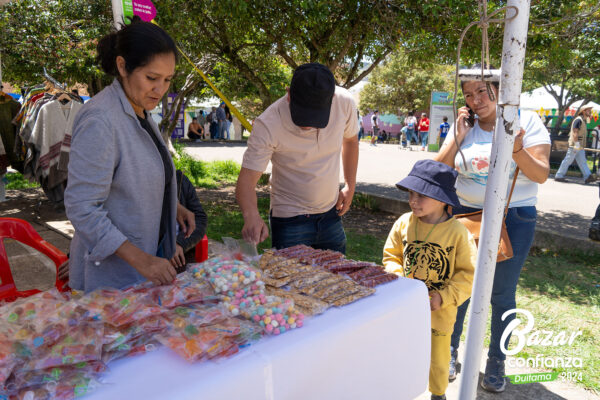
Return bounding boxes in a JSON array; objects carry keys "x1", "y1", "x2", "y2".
[{"x1": 236, "y1": 63, "x2": 358, "y2": 252}]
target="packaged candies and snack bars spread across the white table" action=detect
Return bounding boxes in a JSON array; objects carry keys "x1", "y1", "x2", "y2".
[{"x1": 0, "y1": 245, "x2": 396, "y2": 400}]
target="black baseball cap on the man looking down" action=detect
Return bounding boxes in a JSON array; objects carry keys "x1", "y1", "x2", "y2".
[{"x1": 290, "y1": 63, "x2": 335, "y2": 128}]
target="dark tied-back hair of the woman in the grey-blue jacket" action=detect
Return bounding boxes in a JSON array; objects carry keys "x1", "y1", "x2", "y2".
[{"x1": 96, "y1": 16, "x2": 178, "y2": 77}]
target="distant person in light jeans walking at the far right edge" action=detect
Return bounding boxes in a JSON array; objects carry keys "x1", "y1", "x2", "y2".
[{"x1": 554, "y1": 104, "x2": 596, "y2": 184}]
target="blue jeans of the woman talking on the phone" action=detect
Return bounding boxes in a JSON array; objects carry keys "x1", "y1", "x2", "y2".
[{"x1": 450, "y1": 206, "x2": 537, "y2": 360}]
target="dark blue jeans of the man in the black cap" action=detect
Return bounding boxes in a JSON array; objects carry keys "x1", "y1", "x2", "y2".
[{"x1": 269, "y1": 207, "x2": 346, "y2": 254}]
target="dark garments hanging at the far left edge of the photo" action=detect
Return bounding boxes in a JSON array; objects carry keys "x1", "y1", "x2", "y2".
[{"x1": 0, "y1": 92, "x2": 21, "y2": 175}]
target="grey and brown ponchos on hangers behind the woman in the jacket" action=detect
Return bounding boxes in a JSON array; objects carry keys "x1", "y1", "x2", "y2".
[{"x1": 14, "y1": 88, "x2": 83, "y2": 203}]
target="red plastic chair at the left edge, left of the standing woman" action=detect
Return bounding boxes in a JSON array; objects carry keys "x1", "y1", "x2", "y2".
[{"x1": 0, "y1": 218, "x2": 69, "y2": 301}]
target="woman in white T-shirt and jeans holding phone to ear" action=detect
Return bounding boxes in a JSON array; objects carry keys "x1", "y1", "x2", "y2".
[{"x1": 435, "y1": 65, "x2": 550, "y2": 392}]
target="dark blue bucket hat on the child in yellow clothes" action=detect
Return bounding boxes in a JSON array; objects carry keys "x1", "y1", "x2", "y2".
[{"x1": 396, "y1": 160, "x2": 460, "y2": 207}]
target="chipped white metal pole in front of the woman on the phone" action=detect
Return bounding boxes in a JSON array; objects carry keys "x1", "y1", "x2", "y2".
[{"x1": 458, "y1": 0, "x2": 530, "y2": 400}]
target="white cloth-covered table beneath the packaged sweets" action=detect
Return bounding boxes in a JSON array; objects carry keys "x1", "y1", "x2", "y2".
[{"x1": 86, "y1": 278, "x2": 431, "y2": 400}]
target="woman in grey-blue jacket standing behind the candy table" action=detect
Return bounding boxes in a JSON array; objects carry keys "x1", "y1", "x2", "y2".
[{"x1": 65, "y1": 18, "x2": 195, "y2": 292}]
